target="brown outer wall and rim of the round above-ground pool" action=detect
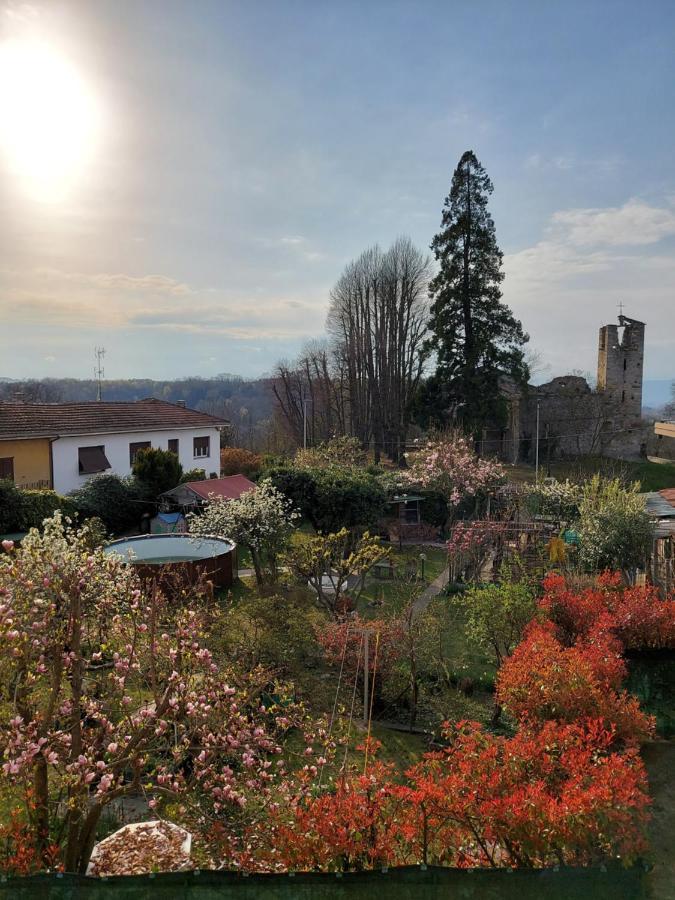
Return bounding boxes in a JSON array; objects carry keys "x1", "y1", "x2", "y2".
[{"x1": 106, "y1": 534, "x2": 238, "y2": 588}]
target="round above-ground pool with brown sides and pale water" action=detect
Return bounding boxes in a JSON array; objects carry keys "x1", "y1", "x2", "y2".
[{"x1": 105, "y1": 534, "x2": 237, "y2": 587}]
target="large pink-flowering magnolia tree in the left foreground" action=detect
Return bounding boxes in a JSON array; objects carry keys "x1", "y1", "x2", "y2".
[{"x1": 0, "y1": 514, "x2": 320, "y2": 872}]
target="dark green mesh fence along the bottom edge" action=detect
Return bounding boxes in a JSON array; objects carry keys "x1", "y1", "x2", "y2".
[{"x1": 0, "y1": 866, "x2": 647, "y2": 900}]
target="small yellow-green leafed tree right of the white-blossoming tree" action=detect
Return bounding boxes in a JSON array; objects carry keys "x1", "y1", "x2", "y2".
[{"x1": 286, "y1": 528, "x2": 389, "y2": 617}]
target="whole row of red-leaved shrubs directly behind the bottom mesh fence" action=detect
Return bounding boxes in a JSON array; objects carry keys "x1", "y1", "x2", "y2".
[{"x1": 239, "y1": 722, "x2": 649, "y2": 871}]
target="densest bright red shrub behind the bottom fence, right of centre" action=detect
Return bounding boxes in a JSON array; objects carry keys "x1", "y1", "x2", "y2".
[{"x1": 396, "y1": 722, "x2": 649, "y2": 866}]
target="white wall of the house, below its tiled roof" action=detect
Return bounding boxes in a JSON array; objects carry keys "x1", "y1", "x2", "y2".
[{"x1": 52, "y1": 428, "x2": 220, "y2": 494}]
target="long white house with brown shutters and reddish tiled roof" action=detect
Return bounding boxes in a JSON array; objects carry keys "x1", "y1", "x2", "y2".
[{"x1": 1, "y1": 399, "x2": 229, "y2": 494}]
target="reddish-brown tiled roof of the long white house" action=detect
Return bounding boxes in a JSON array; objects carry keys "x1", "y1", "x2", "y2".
[{"x1": 0, "y1": 399, "x2": 229, "y2": 440}]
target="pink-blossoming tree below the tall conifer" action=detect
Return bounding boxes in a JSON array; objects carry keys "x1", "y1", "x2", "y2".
[{"x1": 406, "y1": 433, "x2": 504, "y2": 508}]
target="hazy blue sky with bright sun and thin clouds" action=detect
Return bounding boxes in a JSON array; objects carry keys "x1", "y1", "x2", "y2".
[{"x1": 0, "y1": 0, "x2": 675, "y2": 380}]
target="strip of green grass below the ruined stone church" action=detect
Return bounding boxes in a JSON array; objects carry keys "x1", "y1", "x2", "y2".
[{"x1": 506, "y1": 456, "x2": 675, "y2": 492}]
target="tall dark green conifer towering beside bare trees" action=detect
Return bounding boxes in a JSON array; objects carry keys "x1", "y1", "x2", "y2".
[{"x1": 422, "y1": 150, "x2": 529, "y2": 437}]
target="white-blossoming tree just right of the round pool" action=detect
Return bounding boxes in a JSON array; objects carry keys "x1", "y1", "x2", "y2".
[{"x1": 189, "y1": 478, "x2": 300, "y2": 587}]
